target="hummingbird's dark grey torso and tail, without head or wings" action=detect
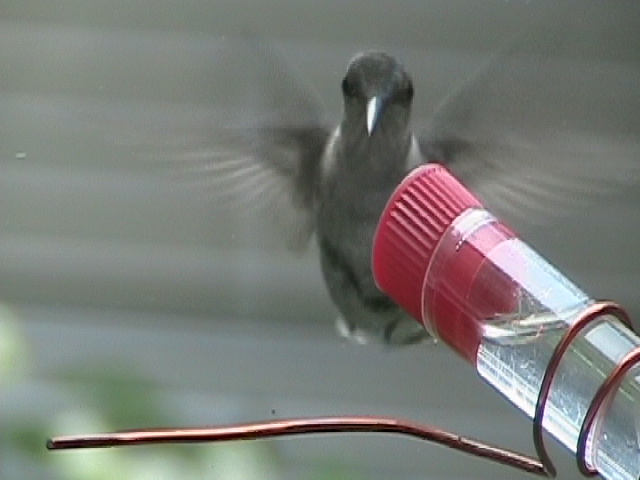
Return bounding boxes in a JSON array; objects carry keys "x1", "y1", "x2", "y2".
[{"x1": 314, "y1": 133, "x2": 427, "y2": 344}]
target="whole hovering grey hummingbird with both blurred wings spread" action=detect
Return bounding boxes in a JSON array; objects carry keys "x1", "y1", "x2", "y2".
[{"x1": 180, "y1": 44, "x2": 639, "y2": 345}]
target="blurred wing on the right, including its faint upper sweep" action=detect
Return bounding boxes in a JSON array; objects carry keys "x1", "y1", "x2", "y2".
[{"x1": 421, "y1": 27, "x2": 640, "y2": 228}]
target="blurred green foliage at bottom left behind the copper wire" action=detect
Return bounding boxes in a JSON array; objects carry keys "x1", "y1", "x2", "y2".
[{"x1": 0, "y1": 305, "x2": 361, "y2": 480}]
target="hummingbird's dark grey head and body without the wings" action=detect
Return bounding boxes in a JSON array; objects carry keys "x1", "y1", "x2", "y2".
[{"x1": 314, "y1": 52, "x2": 428, "y2": 344}]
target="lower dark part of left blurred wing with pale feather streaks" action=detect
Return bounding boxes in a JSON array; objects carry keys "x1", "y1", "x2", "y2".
[{"x1": 178, "y1": 126, "x2": 328, "y2": 250}]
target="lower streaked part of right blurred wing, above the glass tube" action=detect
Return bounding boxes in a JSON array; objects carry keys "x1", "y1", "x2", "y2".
[{"x1": 424, "y1": 135, "x2": 640, "y2": 225}]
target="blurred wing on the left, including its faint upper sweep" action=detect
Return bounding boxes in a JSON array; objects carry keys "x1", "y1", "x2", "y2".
[{"x1": 165, "y1": 39, "x2": 329, "y2": 250}]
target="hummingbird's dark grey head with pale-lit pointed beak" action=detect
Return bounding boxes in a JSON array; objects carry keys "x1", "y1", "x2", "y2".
[{"x1": 342, "y1": 51, "x2": 413, "y2": 137}]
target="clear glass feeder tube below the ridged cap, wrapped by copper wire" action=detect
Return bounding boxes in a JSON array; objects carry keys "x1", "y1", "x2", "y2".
[{"x1": 425, "y1": 209, "x2": 640, "y2": 480}]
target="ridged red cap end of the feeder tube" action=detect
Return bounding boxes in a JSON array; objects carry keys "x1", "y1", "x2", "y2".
[{"x1": 373, "y1": 164, "x2": 481, "y2": 325}]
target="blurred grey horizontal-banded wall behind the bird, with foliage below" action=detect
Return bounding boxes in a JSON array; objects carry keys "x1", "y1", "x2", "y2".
[{"x1": 0, "y1": 0, "x2": 640, "y2": 479}]
